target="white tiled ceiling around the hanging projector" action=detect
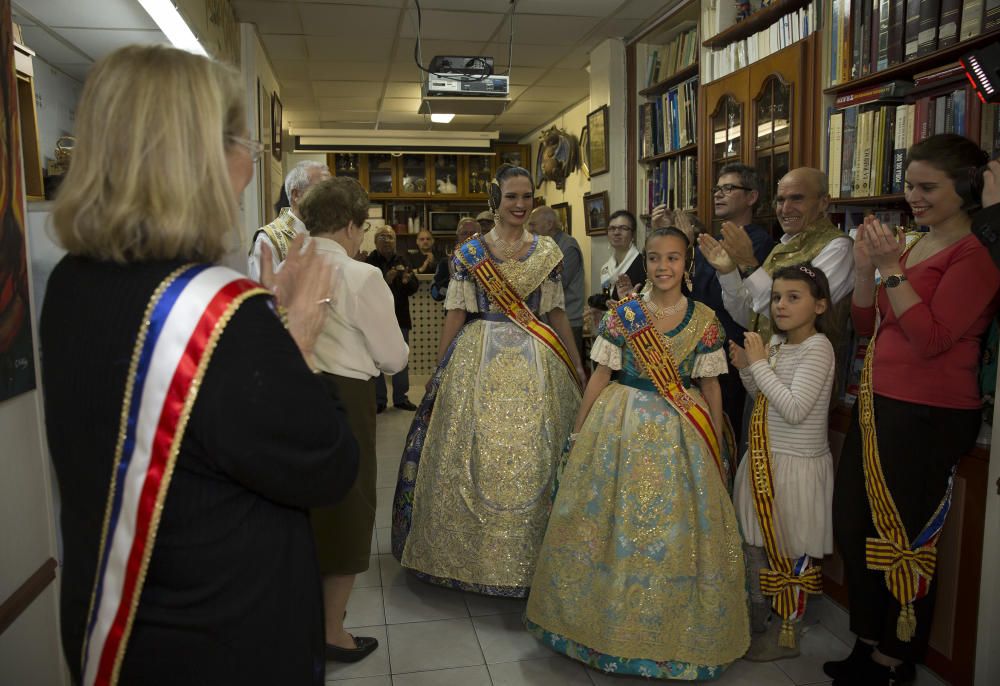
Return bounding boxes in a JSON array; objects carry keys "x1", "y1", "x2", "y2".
[{"x1": 14, "y1": 0, "x2": 679, "y2": 139}]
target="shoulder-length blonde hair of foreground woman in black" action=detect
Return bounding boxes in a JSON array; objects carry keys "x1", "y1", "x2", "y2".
[{"x1": 52, "y1": 45, "x2": 246, "y2": 263}]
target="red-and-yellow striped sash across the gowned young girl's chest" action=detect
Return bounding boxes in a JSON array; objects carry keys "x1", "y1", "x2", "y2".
[{"x1": 615, "y1": 293, "x2": 728, "y2": 485}]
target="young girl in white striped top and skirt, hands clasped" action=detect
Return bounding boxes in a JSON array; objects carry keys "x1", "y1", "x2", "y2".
[{"x1": 730, "y1": 264, "x2": 834, "y2": 661}]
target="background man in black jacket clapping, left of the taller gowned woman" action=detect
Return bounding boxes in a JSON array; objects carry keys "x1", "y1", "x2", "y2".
[{"x1": 365, "y1": 231, "x2": 420, "y2": 414}]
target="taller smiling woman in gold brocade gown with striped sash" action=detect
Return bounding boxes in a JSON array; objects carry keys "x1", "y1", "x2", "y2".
[{"x1": 392, "y1": 165, "x2": 584, "y2": 598}]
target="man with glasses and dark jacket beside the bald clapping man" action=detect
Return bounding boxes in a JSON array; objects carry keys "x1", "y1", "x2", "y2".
[{"x1": 652, "y1": 163, "x2": 774, "y2": 445}]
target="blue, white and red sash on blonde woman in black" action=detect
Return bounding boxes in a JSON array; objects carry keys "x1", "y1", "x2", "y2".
[{"x1": 82, "y1": 264, "x2": 268, "y2": 686}]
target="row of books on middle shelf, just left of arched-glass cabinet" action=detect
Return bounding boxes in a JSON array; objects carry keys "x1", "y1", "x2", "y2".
[{"x1": 639, "y1": 76, "x2": 698, "y2": 158}]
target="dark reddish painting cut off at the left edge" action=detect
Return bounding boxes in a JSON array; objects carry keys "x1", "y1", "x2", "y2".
[{"x1": 0, "y1": 0, "x2": 35, "y2": 401}]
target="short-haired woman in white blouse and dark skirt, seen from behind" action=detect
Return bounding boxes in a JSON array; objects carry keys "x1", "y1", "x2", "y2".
[{"x1": 299, "y1": 177, "x2": 409, "y2": 662}]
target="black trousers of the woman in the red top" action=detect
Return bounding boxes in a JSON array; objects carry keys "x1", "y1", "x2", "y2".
[{"x1": 833, "y1": 395, "x2": 981, "y2": 662}]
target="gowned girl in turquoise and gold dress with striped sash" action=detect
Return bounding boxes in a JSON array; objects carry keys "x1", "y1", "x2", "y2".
[{"x1": 525, "y1": 228, "x2": 750, "y2": 680}]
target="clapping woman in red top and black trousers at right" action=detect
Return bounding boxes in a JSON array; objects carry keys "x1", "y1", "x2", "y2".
[{"x1": 824, "y1": 134, "x2": 1000, "y2": 686}]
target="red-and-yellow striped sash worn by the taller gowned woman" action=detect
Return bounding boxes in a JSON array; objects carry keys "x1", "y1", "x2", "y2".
[{"x1": 458, "y1": 235, "x2": 580, "y2": 387}]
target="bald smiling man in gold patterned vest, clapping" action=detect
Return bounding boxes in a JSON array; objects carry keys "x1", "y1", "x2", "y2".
[{"x1": 699, "y1": 167, "x2": 854, "y2": 345}]
